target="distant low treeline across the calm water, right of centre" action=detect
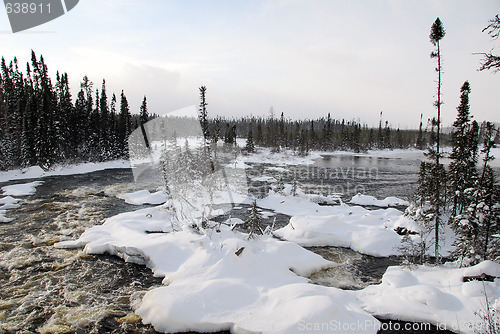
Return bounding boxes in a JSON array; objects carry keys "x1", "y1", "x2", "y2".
[{"x1": 209, "y1": 110, "x2": 498, "y2": 154}]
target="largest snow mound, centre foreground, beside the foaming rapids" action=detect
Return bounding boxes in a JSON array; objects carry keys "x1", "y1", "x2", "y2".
[{"x1": 56, "y1": 206, "x2": 379, "y2": 333}]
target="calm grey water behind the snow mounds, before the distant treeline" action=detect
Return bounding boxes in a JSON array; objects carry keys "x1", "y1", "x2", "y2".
[{"x1": 249, "y1": 155, "x2": 421, "y2": 201}]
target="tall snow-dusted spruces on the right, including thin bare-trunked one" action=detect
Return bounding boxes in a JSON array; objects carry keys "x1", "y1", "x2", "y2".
[{"x1": 402, "y1": 15, "x2": 500, "y2": 265}]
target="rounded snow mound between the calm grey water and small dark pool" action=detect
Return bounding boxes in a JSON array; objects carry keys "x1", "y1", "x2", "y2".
[{"x1": 257, "y1": 194, "x2": 413, "y2": 256}]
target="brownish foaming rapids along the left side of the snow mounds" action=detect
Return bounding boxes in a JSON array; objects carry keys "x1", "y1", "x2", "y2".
[{"x1": 0, "y1": 169, "x2": 166, "y2": 333}]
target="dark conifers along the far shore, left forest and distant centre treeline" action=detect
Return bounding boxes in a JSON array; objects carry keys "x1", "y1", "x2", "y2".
[{"x1": 0, "y1": 51, "x2": 498, "y2": 170}]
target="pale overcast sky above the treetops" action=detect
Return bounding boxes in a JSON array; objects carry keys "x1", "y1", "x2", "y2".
[{"x1": 0, "y1": 0, "x2": 500, "y2": 128}]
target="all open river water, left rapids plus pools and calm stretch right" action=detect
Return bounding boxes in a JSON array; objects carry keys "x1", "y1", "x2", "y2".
[{"x1": 0, "y1": 156, "x2": 470, "y2": 333}]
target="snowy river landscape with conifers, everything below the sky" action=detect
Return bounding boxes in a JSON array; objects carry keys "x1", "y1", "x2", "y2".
[{"x1": 0, "y1": 1, "x2": 500, "y2": 334}]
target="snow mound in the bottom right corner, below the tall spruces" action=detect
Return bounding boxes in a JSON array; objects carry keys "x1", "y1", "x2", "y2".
[{"x1": 355, "y1": 261, "x2": 500, "y2": 333}]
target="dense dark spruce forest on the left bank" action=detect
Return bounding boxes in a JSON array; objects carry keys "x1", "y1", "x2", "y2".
[{"x1": 0, "y1": 51, "x2": 151, "y2": 170}]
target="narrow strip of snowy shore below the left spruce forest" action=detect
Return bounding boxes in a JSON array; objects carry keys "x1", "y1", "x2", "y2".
[{"x1": 0, "y1": 160, "x2": 130, "y2": 182}]
